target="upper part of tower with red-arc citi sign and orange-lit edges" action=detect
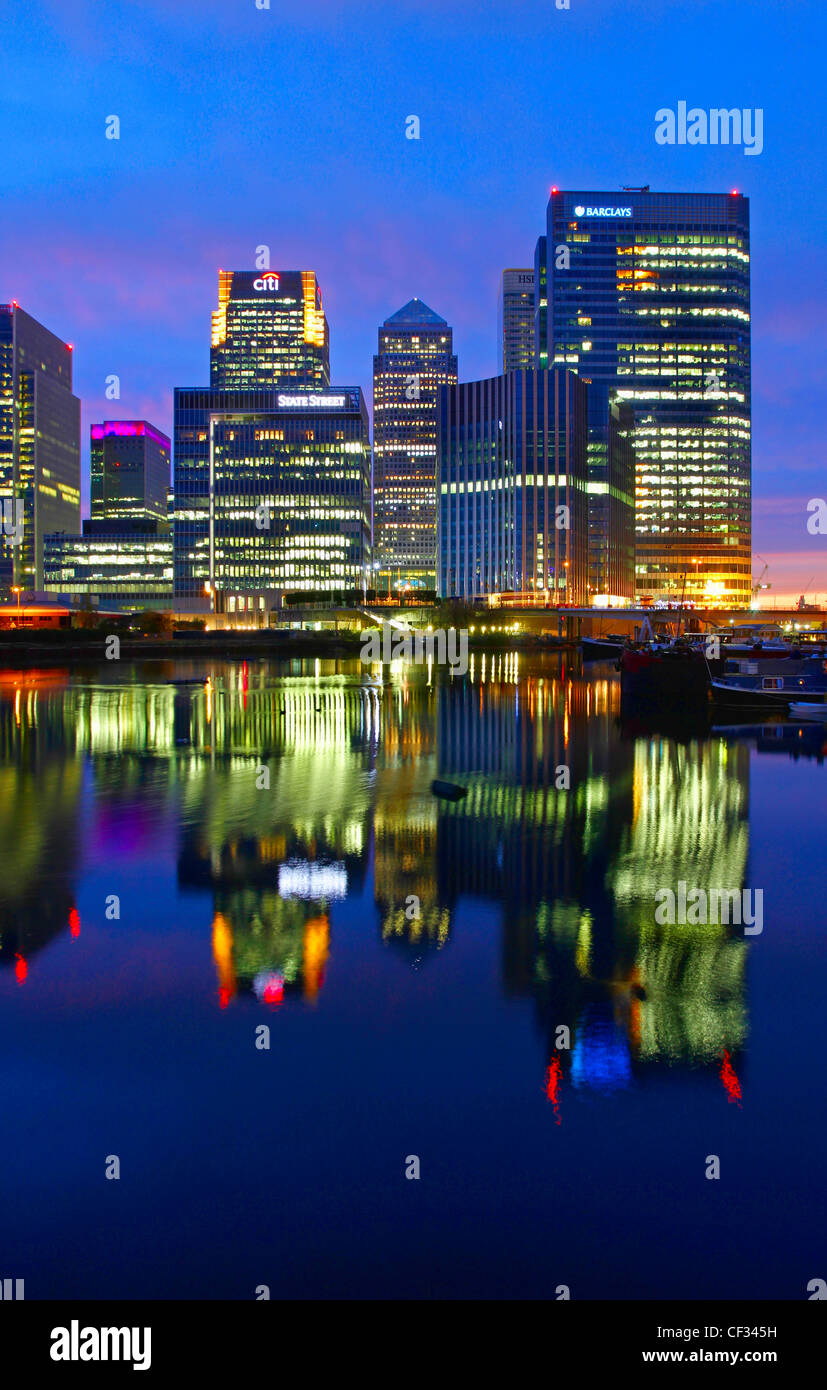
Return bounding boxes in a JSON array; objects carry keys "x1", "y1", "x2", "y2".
[{"x1": 210, "y1": 270, "x2": 331, "y2": 391}]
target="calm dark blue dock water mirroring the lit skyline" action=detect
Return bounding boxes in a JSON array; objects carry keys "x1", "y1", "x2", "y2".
[{"x1": 0, "y1": 656, "x2": 827, "y2": 1300}]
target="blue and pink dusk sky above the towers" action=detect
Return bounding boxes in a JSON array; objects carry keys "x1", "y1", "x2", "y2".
[{"x1": 0, "y1": 0, "x2": 827, "y2": 599}]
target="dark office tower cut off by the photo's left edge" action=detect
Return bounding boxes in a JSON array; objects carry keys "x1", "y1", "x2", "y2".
[{"x1": 0, "y1": 303, "x2": 81, "y2": 591}]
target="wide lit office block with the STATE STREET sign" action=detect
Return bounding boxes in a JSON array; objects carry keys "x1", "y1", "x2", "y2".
[{"x1": 175, "y1": 386, "x2": 370, "y2": 614}]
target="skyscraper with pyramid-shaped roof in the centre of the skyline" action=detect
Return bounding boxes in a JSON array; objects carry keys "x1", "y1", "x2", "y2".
[{"x1": 374, "y1": 299, "x2": 457, "y2": 591}]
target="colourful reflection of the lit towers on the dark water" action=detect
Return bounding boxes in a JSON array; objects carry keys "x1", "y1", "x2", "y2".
[{"x1": 0, "y1": 653, "x2": 824, "y2": 1115}]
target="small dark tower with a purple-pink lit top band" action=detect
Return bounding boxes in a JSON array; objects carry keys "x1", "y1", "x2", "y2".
[{"x1": 90, "y1": 420, "x2": 171, "y2": 521}]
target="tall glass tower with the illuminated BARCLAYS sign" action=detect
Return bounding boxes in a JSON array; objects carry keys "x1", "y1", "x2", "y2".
[{"x1": 537, "y1": 189, "x2": 751, "y2": 605}]
